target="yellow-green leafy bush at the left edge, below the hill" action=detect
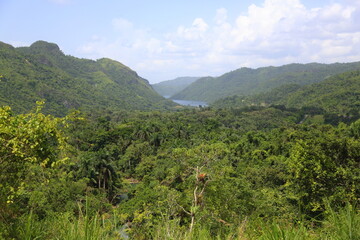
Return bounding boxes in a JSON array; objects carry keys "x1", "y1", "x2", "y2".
[{"x1": 0, "y1": 103, "x2": 67, "y2": 206}]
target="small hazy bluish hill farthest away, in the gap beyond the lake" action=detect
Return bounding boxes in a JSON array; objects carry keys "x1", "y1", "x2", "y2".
[{"x1": 152, "y1": 77, "x2": 199, "y2": 97}]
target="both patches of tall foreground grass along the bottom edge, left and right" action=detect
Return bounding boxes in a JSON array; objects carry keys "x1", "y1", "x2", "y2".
[{"x1": 7, "y1": 202, "x2": 360, "y2": 240}]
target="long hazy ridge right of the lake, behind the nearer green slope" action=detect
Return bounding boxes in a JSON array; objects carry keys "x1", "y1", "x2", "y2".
[{"x1": 172, "y1": 62, "x2": 360, "y2": 103}]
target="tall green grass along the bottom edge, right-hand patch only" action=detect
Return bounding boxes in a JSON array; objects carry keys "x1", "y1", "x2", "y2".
[{"x1": 153, "y1": 204, "x2": 360, "y2": 240}]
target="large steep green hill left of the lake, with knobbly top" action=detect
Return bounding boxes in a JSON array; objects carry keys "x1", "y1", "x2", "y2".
[{"x1": 0, "y1": 41, "x2": 174, "y2": 115}]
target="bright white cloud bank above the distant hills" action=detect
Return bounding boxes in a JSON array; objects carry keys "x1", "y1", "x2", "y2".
[{"x1": 79, "y1": 0, "x2": 360, "y2": 82}]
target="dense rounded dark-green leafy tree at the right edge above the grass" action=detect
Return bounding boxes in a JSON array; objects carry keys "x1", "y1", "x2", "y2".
[{"x1": 286, "y1": 129, "x2": 360, "y2": 216}]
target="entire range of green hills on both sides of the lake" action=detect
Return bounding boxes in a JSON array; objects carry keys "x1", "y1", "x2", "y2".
[{"x1": 0, "y1": 41, "x2": 360, "y2": 116}]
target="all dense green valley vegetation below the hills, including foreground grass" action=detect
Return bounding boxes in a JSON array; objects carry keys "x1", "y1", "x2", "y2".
[{"x1": 0, "y1": 86, "x2": 360, "y2": 239}]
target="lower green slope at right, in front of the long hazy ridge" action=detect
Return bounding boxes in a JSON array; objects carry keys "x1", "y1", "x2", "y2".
[{"x1": 212, "y1": 71, "x2": 360, "y2": 115}]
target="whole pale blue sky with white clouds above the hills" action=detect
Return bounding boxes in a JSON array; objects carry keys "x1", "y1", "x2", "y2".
[{"x1": 0, "y1": 0, "x2": 360, "y2": 83}]
